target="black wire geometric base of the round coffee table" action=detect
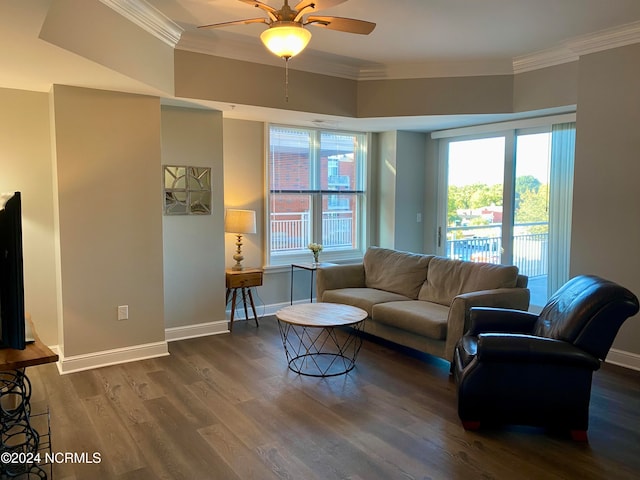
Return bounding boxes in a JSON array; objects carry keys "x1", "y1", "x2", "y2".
[{"x1": 278, "y1": 320, "x2": 364, "y2": 377}]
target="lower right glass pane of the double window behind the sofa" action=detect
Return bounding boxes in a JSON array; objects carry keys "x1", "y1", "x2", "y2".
[{"x1": 322, "y1": 194, "x2": 360, "y2": 251}]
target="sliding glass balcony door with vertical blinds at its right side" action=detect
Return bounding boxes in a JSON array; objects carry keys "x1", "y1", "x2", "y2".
[{"x1": 438, "y1": 116, "x2": 575, "y2": 309}]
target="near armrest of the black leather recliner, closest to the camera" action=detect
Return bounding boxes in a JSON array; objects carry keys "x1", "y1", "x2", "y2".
[{"x1": 476, "y1": 333, "x2": 600, "y2": 370}]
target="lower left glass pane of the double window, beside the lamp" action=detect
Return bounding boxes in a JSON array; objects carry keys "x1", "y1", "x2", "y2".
[{"x1": 269, "y1": 193, "x2": 311, "y2": 255}]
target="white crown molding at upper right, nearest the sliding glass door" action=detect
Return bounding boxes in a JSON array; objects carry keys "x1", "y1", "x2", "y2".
[{"x1": 513, "y1": 22, "x2": 640, "y2": 73}]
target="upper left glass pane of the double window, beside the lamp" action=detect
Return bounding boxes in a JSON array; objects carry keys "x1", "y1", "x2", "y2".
[{"x1": 269, "y1": 127, "x2": 312, "y2": 190}]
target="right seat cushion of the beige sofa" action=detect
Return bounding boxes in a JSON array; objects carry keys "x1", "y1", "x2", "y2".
[{"x1": 371, "y1": 300, "x2": 449, "y2": 340}]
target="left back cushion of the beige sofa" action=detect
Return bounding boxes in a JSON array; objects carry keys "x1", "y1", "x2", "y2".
[{"x1": 363, "y1": 247, "x2": 433, "y2": 300}]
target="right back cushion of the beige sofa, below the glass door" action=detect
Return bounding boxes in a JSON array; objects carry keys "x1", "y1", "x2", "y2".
[{"x1": 418, "y1": 257, "x2": 518, "y2": 306}]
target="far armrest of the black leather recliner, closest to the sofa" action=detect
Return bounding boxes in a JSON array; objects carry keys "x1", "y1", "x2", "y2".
[{"x1": 465, "y1": 307, "x2": 538, "y2": 335}]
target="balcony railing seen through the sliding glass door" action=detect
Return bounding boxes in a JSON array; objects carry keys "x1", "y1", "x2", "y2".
[{"x1": 446, "y1": 222, "x2": 549, "y2": 277}]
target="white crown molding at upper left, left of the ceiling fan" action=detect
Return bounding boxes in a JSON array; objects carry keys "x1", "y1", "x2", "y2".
[{"x1": 100, "y1": 0, "x2": 184, "y2": 48}]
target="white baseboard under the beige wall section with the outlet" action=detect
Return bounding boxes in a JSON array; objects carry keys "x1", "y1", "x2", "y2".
[{"x1": 57, "y1": 342, "x2": 169, "y2": 375}]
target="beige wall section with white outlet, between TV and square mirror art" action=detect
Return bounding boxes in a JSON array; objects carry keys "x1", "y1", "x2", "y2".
[{"x1": 53, "y1": 86, "x2": 164, "y2": 357}]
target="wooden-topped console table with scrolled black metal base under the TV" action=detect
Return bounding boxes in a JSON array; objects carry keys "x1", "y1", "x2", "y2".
[{"x1": 0, "y1": 319, "x2": 58, "y2": 479}]
